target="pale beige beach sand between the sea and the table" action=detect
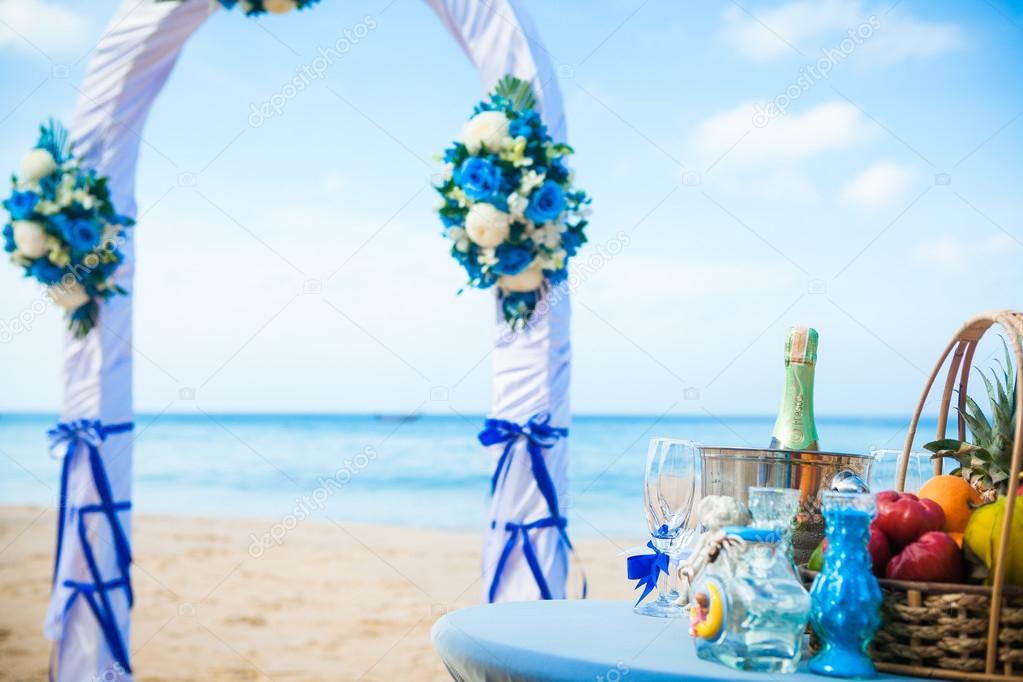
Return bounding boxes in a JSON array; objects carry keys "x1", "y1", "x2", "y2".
[{"x1": 0, "y1": 507, "x2": 634, "y2": 682}]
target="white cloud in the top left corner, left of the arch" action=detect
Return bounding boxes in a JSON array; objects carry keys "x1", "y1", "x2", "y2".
[{"x1": 0, "y1": 0, "x2": 89, "y2": 57}]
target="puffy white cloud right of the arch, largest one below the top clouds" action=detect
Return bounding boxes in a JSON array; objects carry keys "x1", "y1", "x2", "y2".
[{"x1": 691, "y1": 100, "x2": 877, "y2": 168}]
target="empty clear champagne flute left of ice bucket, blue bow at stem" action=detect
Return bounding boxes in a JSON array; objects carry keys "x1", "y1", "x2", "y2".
[{"x1": 635, "y1": 438, "x2": 697, "y2": 618}]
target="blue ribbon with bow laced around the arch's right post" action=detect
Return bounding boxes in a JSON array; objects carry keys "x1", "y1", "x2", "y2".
[{"x1": 479, "y1": 412, "x2": 587, "y2": 603}]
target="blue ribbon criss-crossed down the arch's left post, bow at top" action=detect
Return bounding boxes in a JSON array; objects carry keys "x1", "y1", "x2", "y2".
[{"x1": 47, "y1": 419, "x2": 135, "y2": 677}]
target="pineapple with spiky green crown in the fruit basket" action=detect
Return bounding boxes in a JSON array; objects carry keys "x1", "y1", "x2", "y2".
[{"x1": 924, "y1": 338, "x2": 1019, "y2": 502}]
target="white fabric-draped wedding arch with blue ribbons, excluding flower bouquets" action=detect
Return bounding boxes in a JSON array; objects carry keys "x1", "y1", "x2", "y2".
[{"x1": 46, "y1": 0, "x2": 571, "y2": 680}]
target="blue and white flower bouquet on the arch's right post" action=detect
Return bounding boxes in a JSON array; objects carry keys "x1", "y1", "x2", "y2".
[{"x1": 436, "y1": 76, "x2": 590, "y2": 328}]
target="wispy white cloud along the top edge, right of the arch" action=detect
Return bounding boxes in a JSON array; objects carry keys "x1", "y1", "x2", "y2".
[{"x1": 721, "y1": 0, "x2": 965, "y2": 63}]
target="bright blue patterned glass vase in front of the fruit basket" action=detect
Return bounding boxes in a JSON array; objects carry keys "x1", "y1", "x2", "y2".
[{"x1": 810, "y1": 492, "x2": 882, "y2": 678}]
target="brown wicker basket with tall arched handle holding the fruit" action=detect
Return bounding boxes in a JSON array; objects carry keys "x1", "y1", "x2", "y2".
[{"x1": 872, "y1": 310, "x2": 1023, "y2": 680}]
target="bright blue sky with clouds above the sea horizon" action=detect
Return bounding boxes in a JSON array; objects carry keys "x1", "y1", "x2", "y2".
[{"x1": 0, "y1": 0, "x2": 1023, "y2": 415}]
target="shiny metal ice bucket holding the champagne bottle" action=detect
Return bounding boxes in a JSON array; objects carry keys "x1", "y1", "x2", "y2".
[{"x1": 697, "y1": 445, "x2": 873, "y2": 563}]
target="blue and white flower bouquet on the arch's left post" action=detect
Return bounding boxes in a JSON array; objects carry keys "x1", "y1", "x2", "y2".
[{"x1": 2, "y1": 121, "x2": 134, "y2": 338}]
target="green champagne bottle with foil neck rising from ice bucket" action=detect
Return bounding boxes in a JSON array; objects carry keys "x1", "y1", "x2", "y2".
[{"x1": 770, "y1": 327, "x2": 817, "y2": 450}]
